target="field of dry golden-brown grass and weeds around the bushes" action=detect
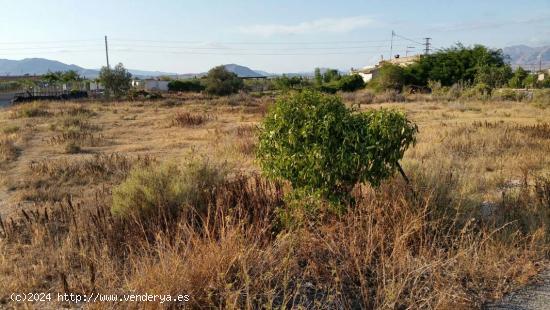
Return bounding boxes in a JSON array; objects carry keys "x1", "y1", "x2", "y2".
[{"x1": 0, "y1": 94, "x2": 550, "y2": 309}]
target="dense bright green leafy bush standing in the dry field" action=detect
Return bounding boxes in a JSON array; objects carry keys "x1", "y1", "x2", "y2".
[{"x1": 257, "y1": 91, "x2": 417, "y2": 203}]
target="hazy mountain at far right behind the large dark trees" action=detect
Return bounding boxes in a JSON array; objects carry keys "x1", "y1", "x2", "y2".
[{"x1": 502, "y1": 45, "x2": 550, "y2": 70}]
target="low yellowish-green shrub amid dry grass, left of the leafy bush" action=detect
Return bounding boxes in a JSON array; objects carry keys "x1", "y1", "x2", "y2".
[{"x1": 111, "y1": 160, "x2": 227, "y2": 217}]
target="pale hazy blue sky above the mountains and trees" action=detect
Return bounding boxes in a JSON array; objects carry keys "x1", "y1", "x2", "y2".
[{"x1": 0, "y1": 0, "x2": 550, "y2": 73}]
